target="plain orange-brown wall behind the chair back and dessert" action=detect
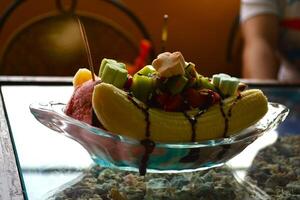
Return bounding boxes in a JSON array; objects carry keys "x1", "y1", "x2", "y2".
[{"x1": 0, "y1": 0, "x2": 240, "y2": 76}]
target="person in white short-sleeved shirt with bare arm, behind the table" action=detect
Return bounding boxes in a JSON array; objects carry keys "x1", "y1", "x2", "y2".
[{"x1": 240, "y1": 0, "x2": 300, "y2": 82}]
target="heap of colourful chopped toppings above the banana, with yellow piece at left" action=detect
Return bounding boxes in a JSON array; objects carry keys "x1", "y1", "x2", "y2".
[{"x1": 92, "y1": 52, "x2": 246, "y2": 112}]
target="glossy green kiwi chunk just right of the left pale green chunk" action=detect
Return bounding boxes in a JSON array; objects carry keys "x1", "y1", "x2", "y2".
[{"x1": 131, "y1": 73, "x2": 155, "y2": 102}]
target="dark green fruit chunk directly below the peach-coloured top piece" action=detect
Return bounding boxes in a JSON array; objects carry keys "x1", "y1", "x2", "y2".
[{"x1": 166, "y1": 75, "x2": 189, "y2": 95}]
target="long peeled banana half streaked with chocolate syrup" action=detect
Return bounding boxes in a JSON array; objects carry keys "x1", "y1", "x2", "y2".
[{"x1": 92, "y1": 83, "x2": 268, "y2": 142}]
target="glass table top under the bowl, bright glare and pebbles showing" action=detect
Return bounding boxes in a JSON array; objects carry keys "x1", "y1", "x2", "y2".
[{"x1": 1, "y1": 85, "x2": 300, "y2": 200}]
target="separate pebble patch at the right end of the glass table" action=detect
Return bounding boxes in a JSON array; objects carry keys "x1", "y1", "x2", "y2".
[{"x1": 248, "y1": 136, "x2": 300, "y2": 200}]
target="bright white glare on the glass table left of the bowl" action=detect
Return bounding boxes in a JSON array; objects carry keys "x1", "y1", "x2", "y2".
[{"x1": 2, "y1": 86, "x2": 92, "y2": 199}]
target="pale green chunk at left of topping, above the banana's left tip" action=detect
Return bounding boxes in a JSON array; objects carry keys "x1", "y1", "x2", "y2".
[{"x1": 99, "y1": 59, "x2": 128, "y2": 89}]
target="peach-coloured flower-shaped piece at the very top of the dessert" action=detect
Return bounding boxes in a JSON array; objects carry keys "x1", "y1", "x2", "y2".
[{"x1": 152, "y1": 52, "x2": 185, "y2": 78}]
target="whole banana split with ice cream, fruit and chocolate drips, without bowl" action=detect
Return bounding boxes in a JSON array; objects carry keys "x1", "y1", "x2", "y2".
[{"x1": 65, "y1": 52, "x2": 268, "y2": 174}]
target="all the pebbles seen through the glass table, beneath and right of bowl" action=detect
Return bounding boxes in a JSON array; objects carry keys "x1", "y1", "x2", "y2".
[{"x1": 48, "y1": 136, "x2": 300, "y2": 200}]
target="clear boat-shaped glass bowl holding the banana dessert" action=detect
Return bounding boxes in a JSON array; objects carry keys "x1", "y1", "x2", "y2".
[{"x1": 30, "y1": 102, "x2": 289, "y2": 173}]
